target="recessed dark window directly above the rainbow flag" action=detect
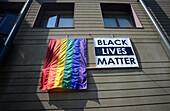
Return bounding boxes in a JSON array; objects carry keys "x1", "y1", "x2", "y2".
[{"x1": 34, "y1": 3, "x2": 74, "y2": 28}]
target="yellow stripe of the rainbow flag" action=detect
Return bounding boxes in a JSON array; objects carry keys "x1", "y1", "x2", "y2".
[{"x1": 54, "y1": 39, "x2": 68, "y2": 88}]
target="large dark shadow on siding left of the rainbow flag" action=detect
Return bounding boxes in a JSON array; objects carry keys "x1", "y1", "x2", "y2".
[{"x1": 0, "y1": 6, "x2": 49, "y2": 111}]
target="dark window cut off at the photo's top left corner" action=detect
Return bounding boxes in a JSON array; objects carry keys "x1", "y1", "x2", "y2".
[{"x1": 0, "y1": 2, "x2": 24, "y2": 52}]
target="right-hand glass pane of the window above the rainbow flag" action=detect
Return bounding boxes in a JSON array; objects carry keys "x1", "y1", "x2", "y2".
[{"x1": 58, "y1": 16, "x2": 73, "y2": 27}]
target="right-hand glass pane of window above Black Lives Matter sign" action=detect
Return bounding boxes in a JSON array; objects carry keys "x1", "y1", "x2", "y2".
[{"x1": 118, "y1": 18, "x2": 132, "y2": 27}]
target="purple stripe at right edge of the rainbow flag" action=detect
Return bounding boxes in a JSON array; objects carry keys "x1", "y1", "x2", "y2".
[{"x1": 79, "y1": 39, "x2": 87, "y2": 89}]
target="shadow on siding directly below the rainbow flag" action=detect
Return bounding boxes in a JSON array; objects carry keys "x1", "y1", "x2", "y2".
[{"x1": 48, "y1": 77, "x2": 100, "y2": 111}]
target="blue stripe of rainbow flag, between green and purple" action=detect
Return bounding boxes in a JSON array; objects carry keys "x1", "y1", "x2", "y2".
[{"x1": 70, "y1": 39, "x2": 80, "y2": 89}]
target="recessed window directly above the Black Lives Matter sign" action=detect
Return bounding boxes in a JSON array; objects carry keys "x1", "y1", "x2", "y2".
[{"x1": 101, "y1": 3, "x2": 142, "y2": 28}]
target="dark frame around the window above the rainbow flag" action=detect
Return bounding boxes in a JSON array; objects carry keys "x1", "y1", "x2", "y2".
[{"x1": 33, "y1": 2, "x2": 75, "y2": 29}]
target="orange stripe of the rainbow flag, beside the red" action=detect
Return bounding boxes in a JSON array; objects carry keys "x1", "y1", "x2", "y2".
[{"x1": 47, "y1": 39, "x2": 62, "y2": 89}]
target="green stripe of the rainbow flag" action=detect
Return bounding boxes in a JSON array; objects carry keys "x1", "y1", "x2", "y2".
[{"x1": 62, "y1": 39, "x2": 74, "y2": 88}]
